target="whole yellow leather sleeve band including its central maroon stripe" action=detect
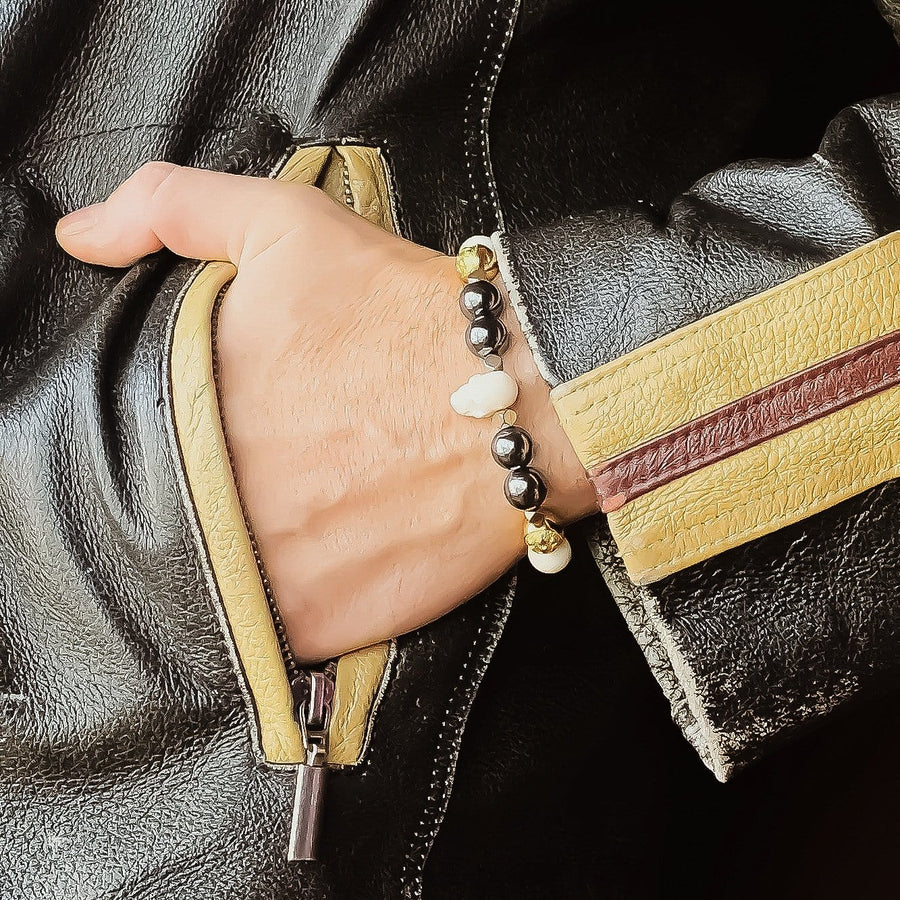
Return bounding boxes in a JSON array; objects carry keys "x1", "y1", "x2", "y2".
[{"x1": 551, "y1": 233, "x2": 900, "y2": 584}]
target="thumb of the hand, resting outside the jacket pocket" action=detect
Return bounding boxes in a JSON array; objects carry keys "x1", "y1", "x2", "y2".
[{"x1": 56, "y1": 162, "x2": 314, "y2": 266}]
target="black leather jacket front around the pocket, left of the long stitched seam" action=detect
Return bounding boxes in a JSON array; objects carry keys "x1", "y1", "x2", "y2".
[{"x1": 0, "y1": 0, "x2": 515, "y2": 900}]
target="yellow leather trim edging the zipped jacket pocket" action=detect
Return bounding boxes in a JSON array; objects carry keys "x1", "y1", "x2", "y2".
[{"x1": 170, "y1": 146, "x2": 395, "y2": 765}]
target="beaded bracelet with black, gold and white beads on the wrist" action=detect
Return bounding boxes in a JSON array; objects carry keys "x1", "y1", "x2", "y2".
[{"x1": 450, "y1": 235, "x2": 572, "y2": 574}]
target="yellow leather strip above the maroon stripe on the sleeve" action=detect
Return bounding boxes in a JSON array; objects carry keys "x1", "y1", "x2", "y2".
[{"x1": 551, "y1": 232, "x2": 900, "y2": 469}]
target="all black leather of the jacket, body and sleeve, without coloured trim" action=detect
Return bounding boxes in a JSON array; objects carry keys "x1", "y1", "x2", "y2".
[{"x1": 0, "y1": 0, "x2": 900, "y2": 900}]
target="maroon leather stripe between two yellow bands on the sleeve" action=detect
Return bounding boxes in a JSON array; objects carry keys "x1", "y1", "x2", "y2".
[{"x1": 588, "y1": 330, "x2": 900, "y2": 512}]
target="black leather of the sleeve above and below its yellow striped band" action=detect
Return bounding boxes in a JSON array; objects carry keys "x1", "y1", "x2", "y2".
[{"x1": 507, "y1": 96, "x2": 900, "y2": 778}]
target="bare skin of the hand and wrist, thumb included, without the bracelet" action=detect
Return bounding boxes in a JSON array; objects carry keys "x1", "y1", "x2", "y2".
[{"x1": 57, "y1": 163, "x2": 595, "y2": 661}]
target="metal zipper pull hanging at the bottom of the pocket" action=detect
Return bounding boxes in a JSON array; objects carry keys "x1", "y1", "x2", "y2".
[{"x1": 288, "y1": 663, "x2": 335, "y2": 862}]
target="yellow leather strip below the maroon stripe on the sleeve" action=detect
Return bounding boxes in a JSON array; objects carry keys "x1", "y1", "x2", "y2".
[{"x1": 609, "y1": 388, "x2": 900, "y2": 584}]
